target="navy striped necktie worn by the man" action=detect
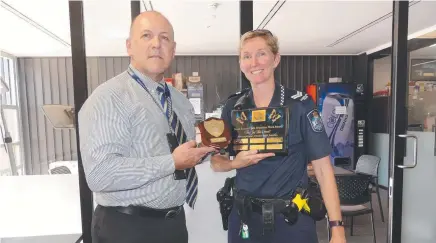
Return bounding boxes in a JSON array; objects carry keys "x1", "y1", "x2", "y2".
[{"x1": 157, "y1": 84, "x2": 198, "y2": 208}]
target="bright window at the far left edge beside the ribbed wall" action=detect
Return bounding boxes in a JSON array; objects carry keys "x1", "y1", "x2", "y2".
[{"x1": 0, "y1": 52, "x2": 24, "y2": 176}]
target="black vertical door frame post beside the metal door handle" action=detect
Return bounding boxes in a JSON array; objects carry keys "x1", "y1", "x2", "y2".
[{"x1": 388, "y1": 1, "x2": 409, "y2": 242}]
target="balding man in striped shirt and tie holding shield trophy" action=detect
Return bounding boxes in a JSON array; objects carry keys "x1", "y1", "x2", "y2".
[{"x1": 79, "y1": 11, "x2": 214, "y2": 243}]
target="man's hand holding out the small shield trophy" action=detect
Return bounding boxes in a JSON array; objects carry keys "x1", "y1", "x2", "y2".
[{"x1": 173, "y1": 141, "x2": 215, "y2": 170}]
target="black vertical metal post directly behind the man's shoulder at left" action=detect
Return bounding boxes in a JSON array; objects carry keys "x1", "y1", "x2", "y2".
[{"x1": 68, "y1": 1, "x2": 94, "y2": 243}]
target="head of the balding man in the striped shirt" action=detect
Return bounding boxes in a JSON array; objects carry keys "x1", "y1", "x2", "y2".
[{"x1": 126, "y1": 14, "x2": 176, "y2": 81}]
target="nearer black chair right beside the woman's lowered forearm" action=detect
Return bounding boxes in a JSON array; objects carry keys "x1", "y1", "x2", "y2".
[{"x1": 327, "y1": 174, "x2": 376, "y2": 243}]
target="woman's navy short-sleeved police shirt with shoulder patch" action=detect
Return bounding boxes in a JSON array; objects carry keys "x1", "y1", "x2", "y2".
[{"x1": 221, "y1": 83, "x2": 331, "y2": 198}]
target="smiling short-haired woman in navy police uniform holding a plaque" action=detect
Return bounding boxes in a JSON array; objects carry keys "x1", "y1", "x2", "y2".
[{"x1": 211, "y1": 30, "x2": 345, "y2": 243}]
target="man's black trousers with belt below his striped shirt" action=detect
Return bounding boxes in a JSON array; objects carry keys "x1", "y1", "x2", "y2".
[{"x1": 91, "y1": 205, "x2": 188, "y2": 243}]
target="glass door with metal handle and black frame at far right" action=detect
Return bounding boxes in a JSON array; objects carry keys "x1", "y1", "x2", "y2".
[{"x1": 388, "y1": 1, "x2": 436, "y2": 243}]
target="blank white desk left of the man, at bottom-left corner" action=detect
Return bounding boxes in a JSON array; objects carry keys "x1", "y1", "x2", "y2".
[{"x1": 0, "y1": 174, "x2": 82, "y2": 238}]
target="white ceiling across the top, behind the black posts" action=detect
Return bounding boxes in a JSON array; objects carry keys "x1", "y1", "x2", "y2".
[{"x1": 0, "y1": 0, "x2": 436, "y2": 56}]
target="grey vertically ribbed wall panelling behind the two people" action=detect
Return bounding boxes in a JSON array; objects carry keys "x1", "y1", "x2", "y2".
[{"x1": 18, "y1": 56, "x2": 354, "y2": 174}]
